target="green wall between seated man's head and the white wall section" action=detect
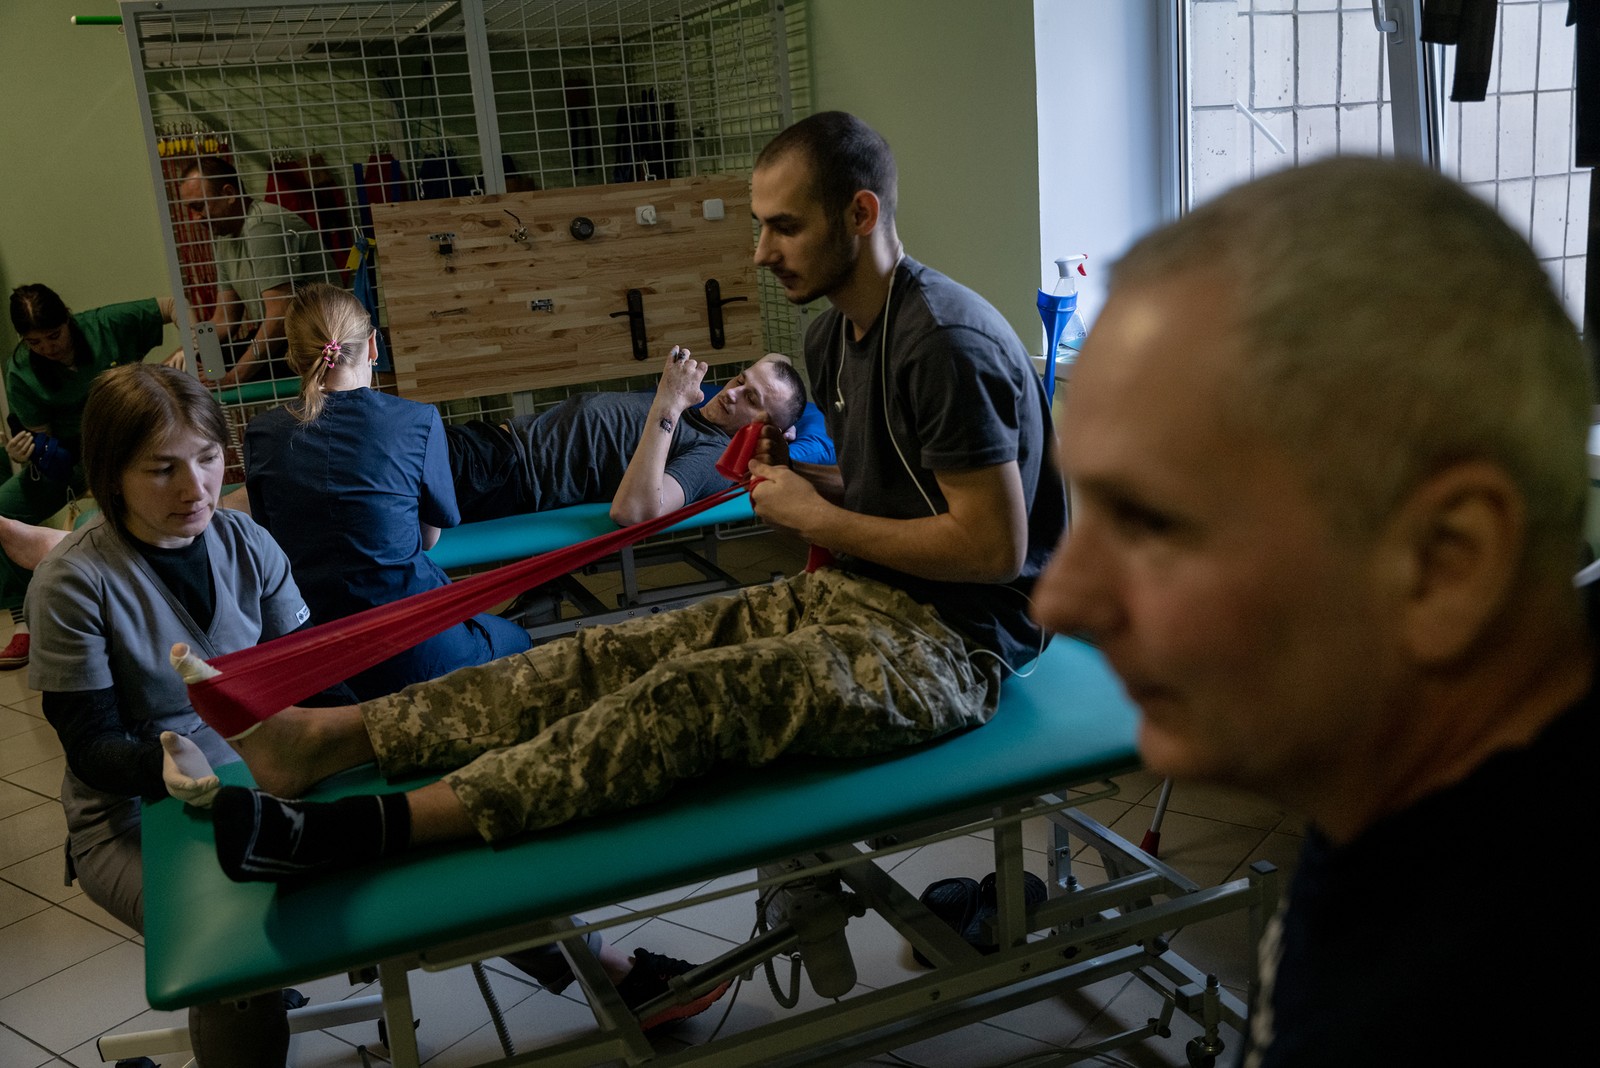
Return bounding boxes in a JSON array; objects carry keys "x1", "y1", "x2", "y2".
[{"x1": 808, "y1": 0, "x2": 1040, "y2": 347}]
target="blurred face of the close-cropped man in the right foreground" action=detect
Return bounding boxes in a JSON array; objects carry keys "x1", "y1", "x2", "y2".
[{"x1": 1034, "y1": 267, "x2": 1392, "y2": 796}]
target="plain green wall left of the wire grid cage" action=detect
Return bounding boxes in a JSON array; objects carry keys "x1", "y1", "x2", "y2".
[{"x1": 0, "y1": 0, "x2": 178, "y2": 357}]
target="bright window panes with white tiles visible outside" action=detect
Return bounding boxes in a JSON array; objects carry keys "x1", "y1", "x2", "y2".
[{"x1": 1187, "y1": 0, "x2": 1590, "y2": 323}]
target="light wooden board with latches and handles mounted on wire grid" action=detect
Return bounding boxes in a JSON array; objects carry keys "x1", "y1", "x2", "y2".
[{"x1": 373, "y1": 176, "x2": 762, "y2": 401}]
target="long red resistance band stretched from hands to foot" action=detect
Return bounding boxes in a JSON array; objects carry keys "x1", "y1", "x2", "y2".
[{"x1": 189, "y1": 424, "x2": 760, "y2": 739}]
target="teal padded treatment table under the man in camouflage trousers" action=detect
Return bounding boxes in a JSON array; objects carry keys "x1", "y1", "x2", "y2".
[{"x1": 144, "y1": 638, "x2": 1275, "y2": 1065}]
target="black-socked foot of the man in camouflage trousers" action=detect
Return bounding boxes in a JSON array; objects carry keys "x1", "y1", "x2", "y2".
[{"x1": 211, "y1": 787, "x2": 411, "y2": 883}]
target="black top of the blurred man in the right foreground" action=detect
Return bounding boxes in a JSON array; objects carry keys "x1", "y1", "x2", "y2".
[{"x1": 1242, "y1": 639, "x2": 1600, "y2": 1068}]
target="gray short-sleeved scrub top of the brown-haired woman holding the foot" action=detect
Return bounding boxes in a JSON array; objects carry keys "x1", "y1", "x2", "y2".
[{"x1": 26, "y1": 510, "x2": 310, "y2": 849}]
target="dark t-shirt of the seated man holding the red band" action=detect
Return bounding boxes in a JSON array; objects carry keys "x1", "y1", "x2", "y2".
[{"x1": 806, "y1": 257, "x2": 1067, "y2": 667}]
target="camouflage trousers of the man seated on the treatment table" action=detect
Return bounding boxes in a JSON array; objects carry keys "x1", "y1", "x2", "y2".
[{"x1": 362, "y1": 569, "x2": 1002, "y2": 841}]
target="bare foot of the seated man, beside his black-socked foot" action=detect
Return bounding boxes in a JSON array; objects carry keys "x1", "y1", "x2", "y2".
[{"x1": 227, "y1": 705, "x2": 373, "y2": 798}]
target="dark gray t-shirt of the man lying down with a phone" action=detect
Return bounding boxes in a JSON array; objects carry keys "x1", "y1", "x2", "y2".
[{"x1": 509, "y1": 392, "x2": 730, "y2": 512}]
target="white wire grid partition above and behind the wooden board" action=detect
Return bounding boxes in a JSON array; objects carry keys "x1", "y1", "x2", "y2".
[{"x1": 123, "y1": 0, "x2": 805, "y2": 422}]
